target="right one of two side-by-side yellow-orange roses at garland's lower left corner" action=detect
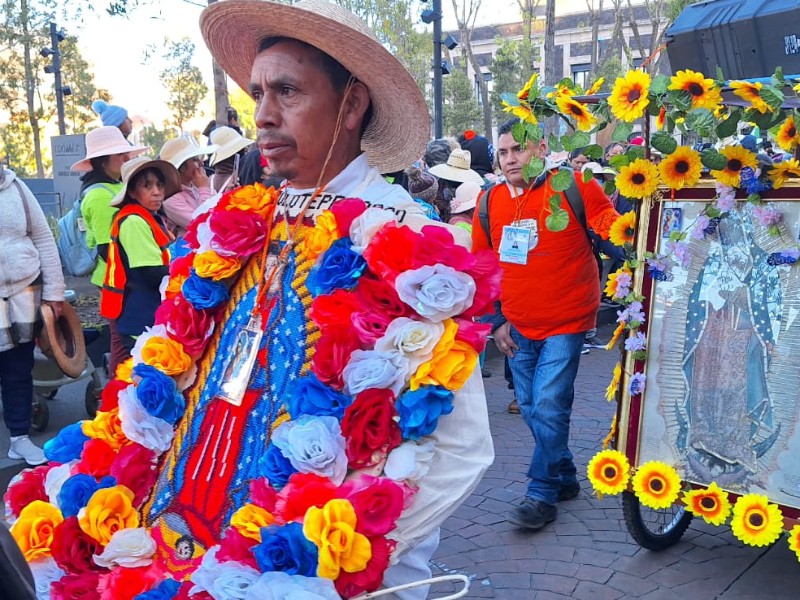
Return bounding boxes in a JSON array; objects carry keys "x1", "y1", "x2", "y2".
[{"x1": 78, "y1": 485, "x2": 139, "y2": 546}]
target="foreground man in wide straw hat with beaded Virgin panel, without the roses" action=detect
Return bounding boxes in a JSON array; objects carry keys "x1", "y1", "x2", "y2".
[{"x1": 143, "y1": 0, "x2": 493, "y2": 599}]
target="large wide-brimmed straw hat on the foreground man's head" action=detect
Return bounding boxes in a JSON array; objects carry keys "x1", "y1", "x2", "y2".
[{"x1": 200, "y1": 0, "x2": 430, "y2": 173}]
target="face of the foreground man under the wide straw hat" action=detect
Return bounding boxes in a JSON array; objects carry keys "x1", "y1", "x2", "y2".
[{"x1": 250, "y1": 42, "x2": 342, "y2": 188}]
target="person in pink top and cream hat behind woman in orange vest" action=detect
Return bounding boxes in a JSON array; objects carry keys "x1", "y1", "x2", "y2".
[{"x1": 158, "y1": 136, "x2": 217, "y2": 237}]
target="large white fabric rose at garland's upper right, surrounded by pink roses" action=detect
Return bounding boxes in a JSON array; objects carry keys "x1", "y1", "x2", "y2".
[{"x1": 395, "y1": 264, "x2": 475, "y2": 321}]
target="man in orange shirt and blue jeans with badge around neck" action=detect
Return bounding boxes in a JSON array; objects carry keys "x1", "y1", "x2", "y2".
[{"x1": 472, "y1": 121, "x2": 619, "y2": 529}]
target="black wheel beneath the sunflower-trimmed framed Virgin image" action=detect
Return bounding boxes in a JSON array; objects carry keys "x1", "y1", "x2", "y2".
[{"x1": 622, "y1": 492, "x2": 692, "y2": 552}]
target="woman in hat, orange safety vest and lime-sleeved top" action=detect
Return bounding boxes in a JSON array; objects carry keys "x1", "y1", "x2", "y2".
[{"x1": 100, "y1": 156, "x2": 181, "y2": 353}]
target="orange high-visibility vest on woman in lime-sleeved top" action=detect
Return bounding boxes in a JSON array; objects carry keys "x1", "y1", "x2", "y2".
[{"x1": 100, "y1": 203, "x2": 172, "y2": 319}]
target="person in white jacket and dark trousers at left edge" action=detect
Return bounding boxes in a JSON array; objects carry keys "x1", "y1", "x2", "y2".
[{"x1": 0, "y1": 166, "x2": 64, "y2": 465}]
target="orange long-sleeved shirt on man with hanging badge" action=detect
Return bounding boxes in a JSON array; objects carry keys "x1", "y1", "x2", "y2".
[{"x1": 472, "y1": 174, "x2": 619, "y2": 340}]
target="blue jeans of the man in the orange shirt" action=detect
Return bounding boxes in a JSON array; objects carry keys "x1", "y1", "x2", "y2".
[{"x1": 508, "y1": 326, "x2": 585, "y2": 504}]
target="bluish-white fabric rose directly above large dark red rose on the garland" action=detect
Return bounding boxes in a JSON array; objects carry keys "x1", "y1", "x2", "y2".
[{"x1": 342, "y1": 350, "x2": 410, "y2": 397}]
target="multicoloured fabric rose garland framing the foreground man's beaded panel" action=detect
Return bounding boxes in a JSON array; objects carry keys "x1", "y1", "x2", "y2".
[{"x1": 5, "y1": 184, "x2": 500, "y2": 600}]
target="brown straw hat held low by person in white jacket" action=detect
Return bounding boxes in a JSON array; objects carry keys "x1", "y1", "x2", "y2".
[{"x1": 39, "y1": 302, "x2": 86, "y2": 378}]
